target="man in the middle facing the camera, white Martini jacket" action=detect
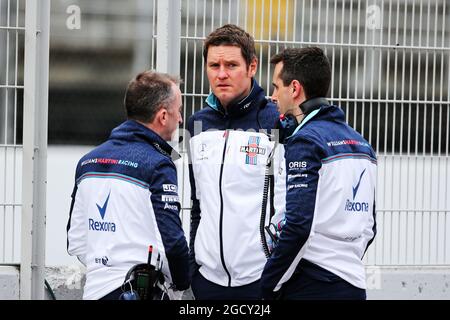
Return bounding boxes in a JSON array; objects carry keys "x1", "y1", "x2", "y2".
[{"x1": 188, "y1": 24, "x2": 284, "y2": 300}]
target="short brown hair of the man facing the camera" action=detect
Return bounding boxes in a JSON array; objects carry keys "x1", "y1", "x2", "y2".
[{"x1": 203, "y1": 24, "x2": 256, "y2": 67}]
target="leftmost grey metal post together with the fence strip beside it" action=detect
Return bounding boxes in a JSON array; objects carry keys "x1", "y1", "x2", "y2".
[{"x1": 0, "y1": 0, "x2": 50, "y2": 299}]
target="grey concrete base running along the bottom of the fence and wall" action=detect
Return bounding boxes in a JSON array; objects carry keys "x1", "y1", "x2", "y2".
[{"x1": 0, "y1": 265, "x2": 450, "y2": 300}]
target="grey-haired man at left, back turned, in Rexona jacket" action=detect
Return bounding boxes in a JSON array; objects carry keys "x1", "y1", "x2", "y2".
[{"x1": 67, "y1": 71, "x2": 189, "y2": 299}]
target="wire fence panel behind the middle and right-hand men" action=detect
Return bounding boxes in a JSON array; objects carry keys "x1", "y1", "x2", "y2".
[{"x1": 173, "y1": 0, "x2": 450, "y2": 265}]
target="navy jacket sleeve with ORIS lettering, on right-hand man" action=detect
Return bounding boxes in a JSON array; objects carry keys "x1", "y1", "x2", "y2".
[{"x1": 261, "y1": 136, "x2": 321, "y2": 299}]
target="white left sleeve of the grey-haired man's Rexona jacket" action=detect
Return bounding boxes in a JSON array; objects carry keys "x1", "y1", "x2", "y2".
[{"x1": 67, "y1": 171, "x2": 87, "y2": 266}]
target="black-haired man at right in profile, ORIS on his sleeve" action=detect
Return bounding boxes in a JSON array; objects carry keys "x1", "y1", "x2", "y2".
[{"x1": 261, "y1": 47, "x2": 377, "y2": 299}]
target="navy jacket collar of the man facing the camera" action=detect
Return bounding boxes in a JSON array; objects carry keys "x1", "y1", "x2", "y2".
[{"x1": 206, "y1": 78, "x2": 264, "y2": 118}]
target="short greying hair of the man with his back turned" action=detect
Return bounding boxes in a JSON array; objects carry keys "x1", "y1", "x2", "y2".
[{"x1": 124, "y1": 70, "x2": 181, "y2": 123}]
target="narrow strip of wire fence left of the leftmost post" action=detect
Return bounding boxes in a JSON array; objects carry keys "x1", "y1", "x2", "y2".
[{"x1": 0, "y1": 1, "x2": 25, "y2": 263}]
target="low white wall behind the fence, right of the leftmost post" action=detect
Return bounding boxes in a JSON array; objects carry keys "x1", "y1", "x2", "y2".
[{"x1": 32, "y1": 146, "x2": 450, "y2": 266}]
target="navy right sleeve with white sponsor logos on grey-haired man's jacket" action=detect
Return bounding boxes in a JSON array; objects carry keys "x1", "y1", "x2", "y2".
[{"x1": 150, "y1": 161, "x2": 190, "y2": 290}]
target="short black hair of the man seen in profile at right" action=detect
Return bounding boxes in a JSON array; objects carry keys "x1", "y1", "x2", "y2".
[{"x1": 270, "y1": 47, "x2": 331, "y2": 99}]
